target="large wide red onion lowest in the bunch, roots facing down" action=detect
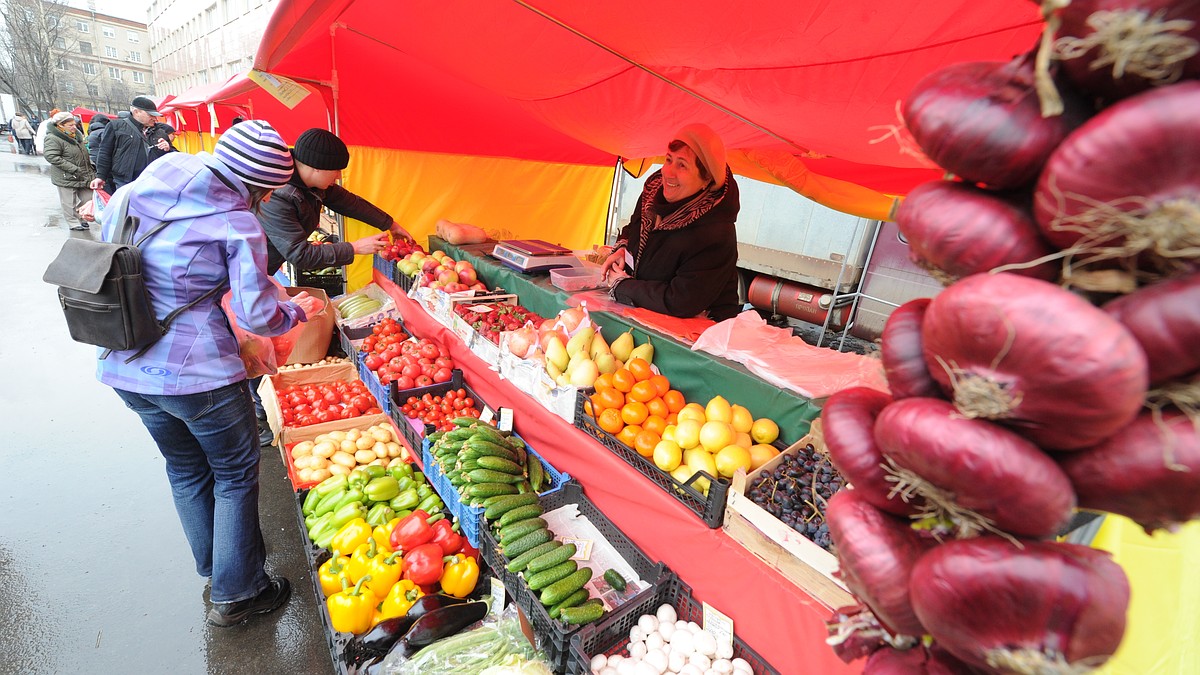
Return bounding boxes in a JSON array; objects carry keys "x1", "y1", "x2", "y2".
[{"x1": 908, "y1": 537, "x2": 1129, "y2": 675}]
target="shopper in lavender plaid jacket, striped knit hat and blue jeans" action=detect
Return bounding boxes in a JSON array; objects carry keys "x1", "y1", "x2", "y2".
[{"x1": 97, "y1": 121, "x2": 319, "y2": 627}]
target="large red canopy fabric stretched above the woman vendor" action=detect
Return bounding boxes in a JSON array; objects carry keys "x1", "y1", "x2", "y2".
[{"x1": 254, "y1": 0, "x2": 1040, "y2": 217}]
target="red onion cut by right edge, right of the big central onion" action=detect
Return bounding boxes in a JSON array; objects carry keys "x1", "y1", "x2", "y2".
[{"x1": 1104, "y1": 271, "x2": 1200, "y2": 387}]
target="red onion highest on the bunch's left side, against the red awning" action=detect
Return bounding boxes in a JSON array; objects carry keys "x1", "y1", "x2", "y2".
[{"x1": 902, "y1": 55, "x2": 1087, "y2": 190}]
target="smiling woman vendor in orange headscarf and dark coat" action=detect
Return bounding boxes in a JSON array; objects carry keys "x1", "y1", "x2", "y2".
[{"x1": 604, "y1": 124, "x2": 742, "y2": 321}]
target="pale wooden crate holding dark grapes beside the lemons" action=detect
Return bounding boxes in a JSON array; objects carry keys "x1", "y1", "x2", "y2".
[{"x1": 724, "y1": 420, "x2": 857, "y2": 609}]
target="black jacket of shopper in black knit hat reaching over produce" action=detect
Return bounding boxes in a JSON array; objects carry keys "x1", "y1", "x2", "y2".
[{"x1": 258, "y1": 168, "x2": 391, "y2": 274}]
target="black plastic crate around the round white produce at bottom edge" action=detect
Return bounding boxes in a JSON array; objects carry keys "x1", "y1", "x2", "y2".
[{"x1": 566, "y1": 574, "x2": 779, "y2": 675}]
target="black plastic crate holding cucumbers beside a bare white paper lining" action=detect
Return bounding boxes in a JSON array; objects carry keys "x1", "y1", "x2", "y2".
[{"x1": 479, "y1": 480, "x2": 668, "y2": 673}]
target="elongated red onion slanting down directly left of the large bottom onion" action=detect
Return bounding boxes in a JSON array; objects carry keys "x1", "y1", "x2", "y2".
[{"x1": 824, "y1": 490, "x2": 932, "y2": 637}]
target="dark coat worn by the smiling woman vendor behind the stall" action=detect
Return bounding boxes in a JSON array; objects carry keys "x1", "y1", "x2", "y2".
[{"x1": 613, "y1": 179, "x2": 742, "y2": 321}]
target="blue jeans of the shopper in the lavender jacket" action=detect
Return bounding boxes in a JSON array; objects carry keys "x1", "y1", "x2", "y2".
[{"x1": 116, "y1": 382, "x2": 269, "y2": 603}]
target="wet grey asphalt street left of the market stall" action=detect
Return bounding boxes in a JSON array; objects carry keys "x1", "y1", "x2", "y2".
[{"x1": 0, "y1": 139, "x2": 334, "y2": 675}]
